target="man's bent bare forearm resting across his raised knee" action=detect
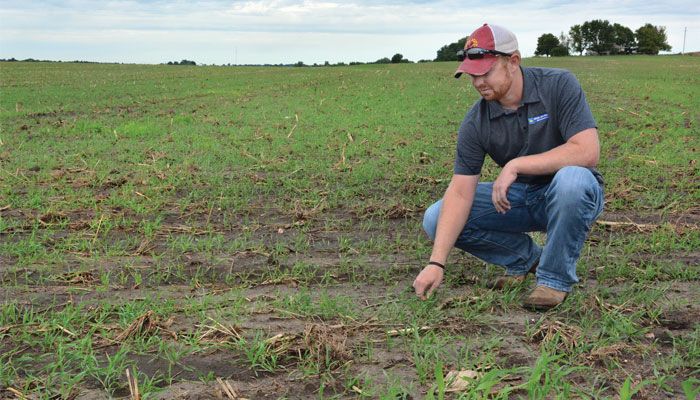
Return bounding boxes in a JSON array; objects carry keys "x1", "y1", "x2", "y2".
[{"x1": 491, "y1": 128, "x2": 600, "y2": 213}]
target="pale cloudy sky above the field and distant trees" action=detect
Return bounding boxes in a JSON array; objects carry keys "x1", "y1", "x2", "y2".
[{"x1": 0, "y1": 0, "x2": 700, "y2": 64}]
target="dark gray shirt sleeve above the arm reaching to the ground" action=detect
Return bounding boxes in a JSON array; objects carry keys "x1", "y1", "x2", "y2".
[{"x1": 454, "y1": 105, "x2": 486, "y2": 175}]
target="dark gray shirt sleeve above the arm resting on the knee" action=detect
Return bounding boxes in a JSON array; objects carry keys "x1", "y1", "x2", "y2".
[{"x1": 558, "y1": 72, "x2": 597, "y2": 140}]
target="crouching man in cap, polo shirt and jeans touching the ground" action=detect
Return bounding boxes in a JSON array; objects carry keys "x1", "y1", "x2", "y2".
[{"x1": 413, "y1": 24, "x2": 603, "y2": 310}]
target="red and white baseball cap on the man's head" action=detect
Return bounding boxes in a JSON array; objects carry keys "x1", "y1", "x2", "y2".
[{"x1": 455, "y1": 24, "x2": 518, "y2": 78}]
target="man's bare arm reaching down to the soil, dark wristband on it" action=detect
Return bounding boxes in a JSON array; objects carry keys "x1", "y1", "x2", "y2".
[{"x1": 413, "y1": 175, "x2": 479, "y2": 300}]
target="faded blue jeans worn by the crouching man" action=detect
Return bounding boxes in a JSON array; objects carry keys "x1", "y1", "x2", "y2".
[{"x1": 423, "y1": 167, "x2": 603, "y2": 292}]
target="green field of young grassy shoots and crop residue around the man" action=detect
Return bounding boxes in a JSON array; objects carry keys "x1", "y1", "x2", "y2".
[{"x1": 0, "y1": 56, "x2": 700, "y2": 399}]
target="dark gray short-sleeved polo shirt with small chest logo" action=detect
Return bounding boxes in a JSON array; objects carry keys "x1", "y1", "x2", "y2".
[{"x1": 454, "y1": 67, "x2": 603, "y2": 184}]
